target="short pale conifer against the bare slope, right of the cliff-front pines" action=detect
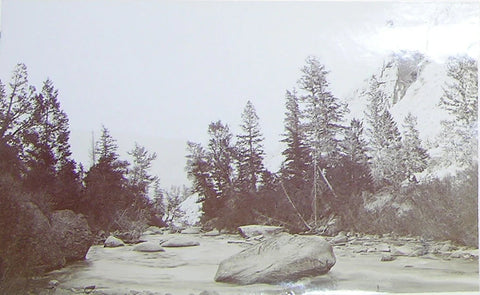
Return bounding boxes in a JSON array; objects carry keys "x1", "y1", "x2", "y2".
[{"x1": 402, "y1": 113, "x2": 429, "y2": 182}]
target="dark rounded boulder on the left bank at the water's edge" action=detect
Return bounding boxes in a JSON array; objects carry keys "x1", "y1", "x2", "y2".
[{"x1": 50, "y1": 210, "x2": 93, "y2": 262}]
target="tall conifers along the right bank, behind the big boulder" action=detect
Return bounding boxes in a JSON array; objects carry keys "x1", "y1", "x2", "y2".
[{"x1": 186, "y1": 57, "x2": 478, "y2": 236}]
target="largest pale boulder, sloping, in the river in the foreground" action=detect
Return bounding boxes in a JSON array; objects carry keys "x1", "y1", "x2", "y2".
[{"x1": 215, "y1": 233, "x2": 336, "y2": 285}]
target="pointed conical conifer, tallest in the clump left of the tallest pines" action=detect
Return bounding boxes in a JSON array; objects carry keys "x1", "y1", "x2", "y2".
[{"x1": 236, "y1": 101, "x2": 265, "y2": 192}]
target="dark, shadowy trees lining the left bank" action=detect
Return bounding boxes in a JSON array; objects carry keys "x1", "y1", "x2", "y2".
[{"x1": 0, "y1": 64, "x2": 176, "y2": 243}]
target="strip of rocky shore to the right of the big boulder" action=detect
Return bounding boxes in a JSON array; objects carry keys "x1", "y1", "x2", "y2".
[{"x1": 328, "y1": 232, "x2": 478, "y2": 261}]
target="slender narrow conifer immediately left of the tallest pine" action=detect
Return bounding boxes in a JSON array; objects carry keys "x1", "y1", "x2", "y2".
[{"x1": 280, "y1": 90, "x2": 310, "y2": 187}]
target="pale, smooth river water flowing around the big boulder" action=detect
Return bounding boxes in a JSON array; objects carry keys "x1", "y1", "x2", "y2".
[{"x1": 35, "y1": 235, "x2": 479, "y2": 295}]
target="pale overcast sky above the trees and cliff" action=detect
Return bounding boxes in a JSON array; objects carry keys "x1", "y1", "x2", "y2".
[{"x1": 0, "y1": 0, "x2": 480, "y2": 187}]
